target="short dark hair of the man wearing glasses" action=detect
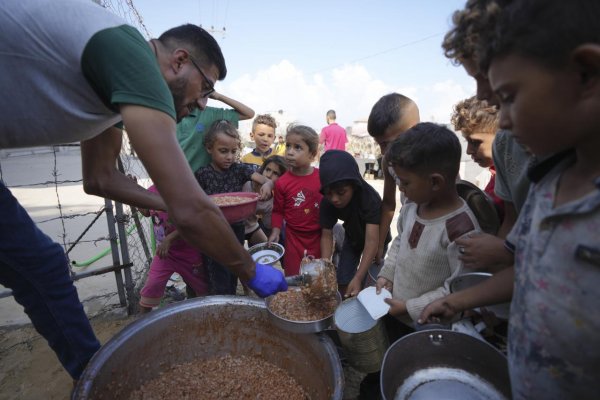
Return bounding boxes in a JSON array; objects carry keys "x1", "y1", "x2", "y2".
[{"x1": 158, "y1": 24, "x2": 227, "y2": 81}]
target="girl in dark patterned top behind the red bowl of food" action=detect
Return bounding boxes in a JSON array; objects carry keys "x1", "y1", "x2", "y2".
[{"x1": 196, "y1": 120, "x2": 273, "y2": 294}]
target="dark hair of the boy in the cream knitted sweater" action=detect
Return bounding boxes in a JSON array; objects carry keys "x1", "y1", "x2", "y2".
[{"x1": 385, "y1": 122, "x2": 462, "y2": 182}]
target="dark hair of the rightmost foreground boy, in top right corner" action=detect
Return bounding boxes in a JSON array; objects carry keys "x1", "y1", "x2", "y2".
[{"x1": 481, "y1": 0, "x2": 600, "y2": 71}]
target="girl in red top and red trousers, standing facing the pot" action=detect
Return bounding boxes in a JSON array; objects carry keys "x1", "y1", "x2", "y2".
[{"x1": 269, "y1": 125, "x2": 323, "y2": 276}]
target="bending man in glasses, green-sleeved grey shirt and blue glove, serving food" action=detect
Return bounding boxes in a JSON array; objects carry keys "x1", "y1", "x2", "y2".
[{"x1": 0, "y1": 0, "x2": 287, "y2": 379}]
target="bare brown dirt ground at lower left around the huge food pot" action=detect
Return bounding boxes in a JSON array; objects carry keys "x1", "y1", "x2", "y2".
[{"x1": 0, "y1": 304, "x2": 363, "y2": 400}]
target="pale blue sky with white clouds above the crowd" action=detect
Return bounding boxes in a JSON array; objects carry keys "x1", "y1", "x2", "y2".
[{"x1": 134, "y1": 0, "x2": 475, "y2": 131}]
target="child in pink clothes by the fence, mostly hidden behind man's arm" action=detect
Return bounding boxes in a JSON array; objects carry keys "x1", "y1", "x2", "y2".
[{"x1": 140, "y1": 186, "x2": 208, "y2": 313}]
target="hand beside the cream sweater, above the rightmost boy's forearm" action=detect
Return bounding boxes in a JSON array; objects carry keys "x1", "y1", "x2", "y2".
[{"x1": 456, "y1": 233, "x2": 513, "y2": 272}]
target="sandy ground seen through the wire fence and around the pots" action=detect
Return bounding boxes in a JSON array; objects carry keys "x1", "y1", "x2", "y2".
[{"x1": 0, "y1": 151, "x2": 486, "y2": 400}]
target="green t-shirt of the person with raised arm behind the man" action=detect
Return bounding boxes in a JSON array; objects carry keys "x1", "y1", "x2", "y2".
[{"x1": 177, "y1": 107, "x2": 240, "y2": 172}]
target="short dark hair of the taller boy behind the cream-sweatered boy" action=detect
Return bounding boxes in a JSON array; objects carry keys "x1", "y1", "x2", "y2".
[{"x1": 367, "y1": 93, "x2": 414, "y2": 137}]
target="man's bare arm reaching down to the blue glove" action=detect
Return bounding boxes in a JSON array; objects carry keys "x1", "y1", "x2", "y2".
[{"x1": 103, "y1": 105, "x2": 255, "y2": 281}]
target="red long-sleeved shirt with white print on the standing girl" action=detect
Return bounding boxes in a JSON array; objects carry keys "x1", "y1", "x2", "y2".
[{"x1": 271, "y1": 168, "x2": 323, "y2": 232}]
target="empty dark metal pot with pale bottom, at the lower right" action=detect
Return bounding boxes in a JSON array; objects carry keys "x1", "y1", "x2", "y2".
[{"x1": 381, "y1": 330, "x2": 511, "y2": 400}]
